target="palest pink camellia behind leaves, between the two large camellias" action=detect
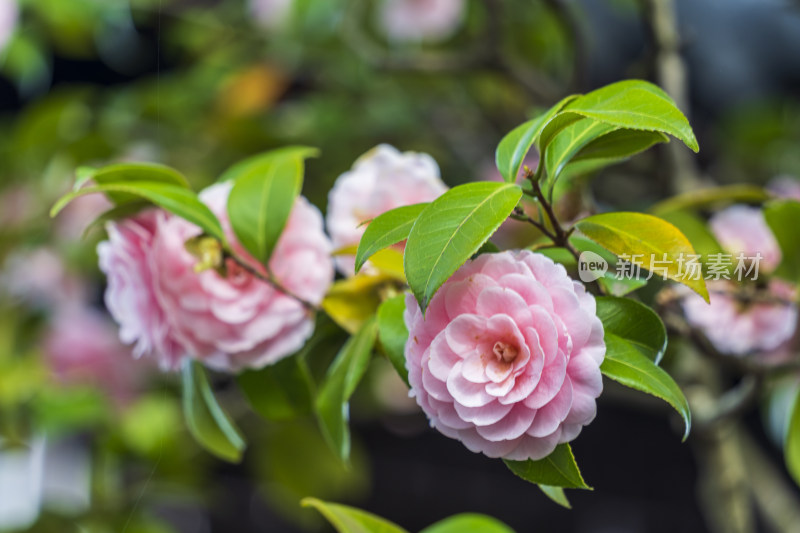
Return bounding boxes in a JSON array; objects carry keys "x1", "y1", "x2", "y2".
[{"x1": 327, "y1": 144, "x2": 447, "y2": 276}]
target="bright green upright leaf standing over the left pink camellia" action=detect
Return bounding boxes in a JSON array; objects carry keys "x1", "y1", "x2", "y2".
[{"x1": 228, "y1": 148, "x2": 314, "y2": 264}]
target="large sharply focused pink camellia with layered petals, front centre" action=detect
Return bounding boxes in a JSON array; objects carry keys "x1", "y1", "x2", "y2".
[{"x1": 405, "y1": 250, "x2": 605, "y2": 460}]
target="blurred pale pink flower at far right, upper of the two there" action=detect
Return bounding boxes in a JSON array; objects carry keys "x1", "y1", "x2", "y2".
[{"x1": 708, "y1": 205, "x2": 781, "y2": 273}]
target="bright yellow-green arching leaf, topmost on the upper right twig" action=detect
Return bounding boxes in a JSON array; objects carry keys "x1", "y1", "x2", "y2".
[{"x1": 561, "y1": 80, "x2": 699, "y2": 152}]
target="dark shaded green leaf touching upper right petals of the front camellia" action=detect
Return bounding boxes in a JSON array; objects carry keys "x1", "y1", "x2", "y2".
[{"x1": 595, "y1": 296, "x2": 667, "y2": 364}]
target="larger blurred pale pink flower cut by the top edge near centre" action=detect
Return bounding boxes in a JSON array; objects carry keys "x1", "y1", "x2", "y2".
[{"x1": 377, "y1": 0, "x2": 466, "y2": 41}]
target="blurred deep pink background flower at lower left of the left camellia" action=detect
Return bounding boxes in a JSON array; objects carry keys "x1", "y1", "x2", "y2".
[{"x1": 44, "y1": 303, "x2": 144, "y2": 405}]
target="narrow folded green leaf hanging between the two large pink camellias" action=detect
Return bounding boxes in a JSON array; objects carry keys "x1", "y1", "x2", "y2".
[{"x1": 315, "y1": 317, "x2": 378, "y2": 461}]
